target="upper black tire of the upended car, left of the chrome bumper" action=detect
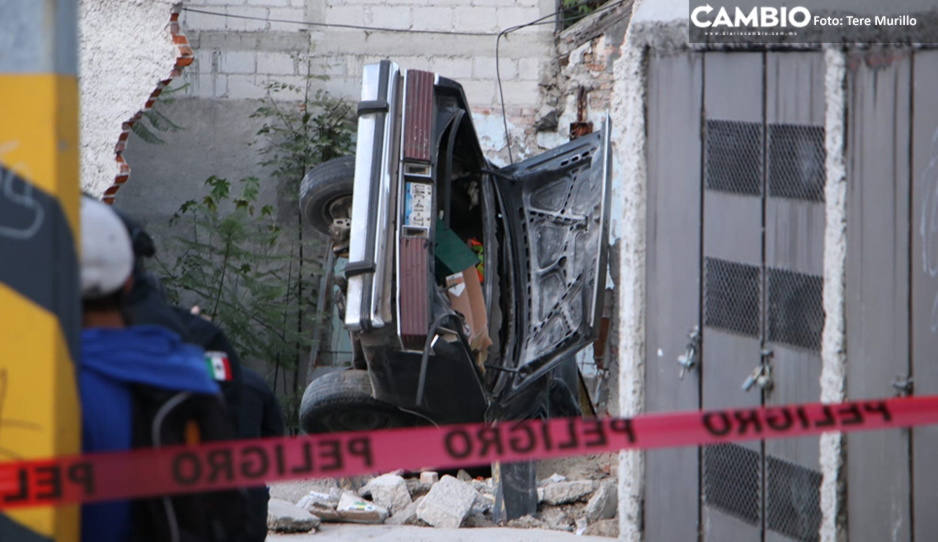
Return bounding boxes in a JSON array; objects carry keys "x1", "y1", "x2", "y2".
[{"x1": 300, "y1": 156, "x2": 355, "y2": 235}]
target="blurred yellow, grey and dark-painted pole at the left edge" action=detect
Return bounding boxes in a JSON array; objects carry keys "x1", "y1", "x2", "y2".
[{"x1": 0, "y1": 0, "x2": 81, "y2": 542}]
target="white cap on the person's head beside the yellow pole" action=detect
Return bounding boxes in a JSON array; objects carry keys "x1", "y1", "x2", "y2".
[{"x1": 81, "y1": 197, "x2": 134, "y2": 299}]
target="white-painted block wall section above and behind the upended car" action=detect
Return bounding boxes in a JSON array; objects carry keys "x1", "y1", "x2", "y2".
[{"x1": 176, "y1": 0, "x2": 556, "y2": 162}]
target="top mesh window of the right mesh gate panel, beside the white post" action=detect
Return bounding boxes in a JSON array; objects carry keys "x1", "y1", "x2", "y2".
[{"x1": 768, "y1": 124, "x2": 827, "y2": 201}]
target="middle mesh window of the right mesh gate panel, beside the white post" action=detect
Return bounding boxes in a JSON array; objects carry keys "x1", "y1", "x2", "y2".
[{"x1": 766, "y1": 268, "x2": 824, "y2": 351}]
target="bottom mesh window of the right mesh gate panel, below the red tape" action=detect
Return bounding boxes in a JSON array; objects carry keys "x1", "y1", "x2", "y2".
[{"x1": 765, "y1": 456, "x2": 821, "y2": 541}]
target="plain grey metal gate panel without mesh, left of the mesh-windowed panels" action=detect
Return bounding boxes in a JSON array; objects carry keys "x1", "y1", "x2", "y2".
[{"x1": 644, "y1": 54, "x2": 703, "y2": 540}]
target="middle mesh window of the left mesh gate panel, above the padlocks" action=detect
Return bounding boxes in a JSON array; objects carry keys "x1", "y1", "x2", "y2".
[{"x1": 704, "y1": 258, "x2": 762, "y2": 337}]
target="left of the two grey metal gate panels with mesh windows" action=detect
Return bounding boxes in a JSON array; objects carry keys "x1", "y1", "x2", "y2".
[{"x1": 700, "y1": 52, "x2": 765, "y2": 541}]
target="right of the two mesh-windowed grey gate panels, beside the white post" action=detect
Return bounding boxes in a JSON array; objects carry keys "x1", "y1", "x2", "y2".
[{"x1": 754, "y1": 52, "x2": 825, "y2": 541}]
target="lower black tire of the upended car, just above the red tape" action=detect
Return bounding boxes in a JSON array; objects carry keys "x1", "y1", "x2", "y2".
[{"x1": 300, "y1": 369, "x2": 414, "y2": 433}]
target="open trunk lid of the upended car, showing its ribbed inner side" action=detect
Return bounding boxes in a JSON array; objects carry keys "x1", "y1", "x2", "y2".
[{"x1": 496, "y1": 117, "x2": 612, "y2": 399}]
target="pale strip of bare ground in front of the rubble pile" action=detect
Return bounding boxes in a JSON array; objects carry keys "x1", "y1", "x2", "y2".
[{"x1": 267, "y1": 523, "x2": 611, "y2": 542}]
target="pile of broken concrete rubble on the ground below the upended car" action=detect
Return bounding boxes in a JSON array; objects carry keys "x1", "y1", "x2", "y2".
[{"x1": 268, "y1": 471, "x2": 619, "y2": 538}]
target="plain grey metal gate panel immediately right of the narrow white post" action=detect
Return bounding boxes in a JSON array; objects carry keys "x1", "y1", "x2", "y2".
[{"x1": 846, "y1": 49, "x2": 908, "y2": 540}]
